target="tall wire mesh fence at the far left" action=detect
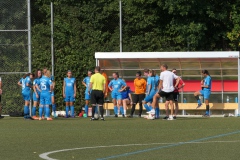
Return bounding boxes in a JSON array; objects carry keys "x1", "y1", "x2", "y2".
[{"x1": 0, "y1": 0, "x2": 31, "y2": 114}]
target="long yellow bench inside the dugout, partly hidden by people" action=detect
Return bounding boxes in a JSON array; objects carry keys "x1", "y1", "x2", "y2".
[{"x1": 104, "y1": 103, "x2": 238, "y2": 115}]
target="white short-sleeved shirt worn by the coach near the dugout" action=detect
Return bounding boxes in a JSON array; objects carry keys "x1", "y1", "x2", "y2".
[{"x1": 160, "y1": 71, "x2": 178, "y2": 93}]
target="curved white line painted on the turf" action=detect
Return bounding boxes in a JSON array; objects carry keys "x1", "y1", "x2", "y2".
[{"x1": 39, "y1": 140, "x2": 240, "y2": 160}]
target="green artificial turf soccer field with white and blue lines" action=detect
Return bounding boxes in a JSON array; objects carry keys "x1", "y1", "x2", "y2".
[{"x1": 0, "y1": 117, "x2": 240, "y2": 160}]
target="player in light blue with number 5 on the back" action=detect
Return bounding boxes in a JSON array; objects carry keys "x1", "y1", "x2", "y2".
[{"x1": 38, "y1": 70, "x2": 53, "y2": 121}]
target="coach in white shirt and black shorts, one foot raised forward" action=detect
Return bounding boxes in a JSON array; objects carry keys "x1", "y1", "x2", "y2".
[{"x1": 149, "y1": 64, "x2": 180, "y2": 120}]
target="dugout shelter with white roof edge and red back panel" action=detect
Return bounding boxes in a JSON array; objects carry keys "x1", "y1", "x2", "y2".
[{"x1": 95, "y1": 51, "x2": 240, "y2": 115}]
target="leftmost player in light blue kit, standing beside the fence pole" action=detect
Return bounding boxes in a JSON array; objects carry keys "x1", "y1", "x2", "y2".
[{"x1": 18, "y1": 73, "x2": 33, "y2": 120}]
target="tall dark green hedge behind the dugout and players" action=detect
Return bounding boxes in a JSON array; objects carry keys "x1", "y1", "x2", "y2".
[{"x1": 32, "y1": 0, "x2": 240, "y2": 111}]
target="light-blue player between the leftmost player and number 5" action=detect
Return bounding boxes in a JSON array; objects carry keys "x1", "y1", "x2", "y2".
[{"x1": 32, "y1": 69, "x2": 42, "y2": 120}]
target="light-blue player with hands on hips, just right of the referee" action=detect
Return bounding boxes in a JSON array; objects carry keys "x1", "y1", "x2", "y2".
[{"x1": 108, "y1": 72, "x2": 127, "y2": 117}]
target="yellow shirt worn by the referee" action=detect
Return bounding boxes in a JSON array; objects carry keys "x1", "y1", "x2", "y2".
[{"x1": 90, "y1": 73, "x2": 106, "y2": 91}]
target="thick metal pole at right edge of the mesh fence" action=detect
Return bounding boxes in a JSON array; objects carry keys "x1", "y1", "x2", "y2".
[{"x1": 27, "y1": 0, "x2": 32, "y2": 116}]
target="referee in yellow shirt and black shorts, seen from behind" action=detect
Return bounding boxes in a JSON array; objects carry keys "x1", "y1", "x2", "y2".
[{"x1": 88, "y1": 66, "x2": 106, "y2": 121}]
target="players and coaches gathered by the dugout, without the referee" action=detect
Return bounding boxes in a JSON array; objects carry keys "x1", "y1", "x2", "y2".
[{"x1": 18, "y1": 64, "x2": 211, "y2": 120}]
